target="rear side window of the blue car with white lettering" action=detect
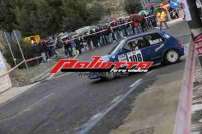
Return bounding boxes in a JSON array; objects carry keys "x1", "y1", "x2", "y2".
[{"x1": 145, "y1": 33, "x2": 164, "y2": 45}]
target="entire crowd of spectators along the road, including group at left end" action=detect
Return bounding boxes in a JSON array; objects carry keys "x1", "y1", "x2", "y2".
[{"x1": 35, "y1": 9, "x2": 170, "y2": 61}]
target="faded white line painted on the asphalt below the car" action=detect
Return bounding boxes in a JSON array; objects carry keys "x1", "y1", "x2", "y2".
[{"x1": 77, "y1": 79, "x2": 142, "y2": 134}]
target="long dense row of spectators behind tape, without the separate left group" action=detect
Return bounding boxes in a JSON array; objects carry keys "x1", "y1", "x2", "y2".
[{"x1": 57, "y1": 14, "x2": 157, "y2": 57}]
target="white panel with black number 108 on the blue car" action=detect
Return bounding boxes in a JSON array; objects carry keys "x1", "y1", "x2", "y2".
[{"x1": 126, "y1": 50, "x2": 143, "y2": 62}]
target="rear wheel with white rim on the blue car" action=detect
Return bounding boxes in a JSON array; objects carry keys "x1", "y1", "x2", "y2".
[{"x1": 164, "y1": 49, "x2": 180, "y2": 64}]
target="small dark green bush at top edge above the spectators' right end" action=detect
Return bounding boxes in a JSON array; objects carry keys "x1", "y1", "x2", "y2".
[{"x1": 125, "y1": 0, "x2": 143, "y2": 14}]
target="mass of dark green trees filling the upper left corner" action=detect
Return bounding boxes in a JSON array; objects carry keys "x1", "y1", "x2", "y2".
[{"x1": 0, "y1": 0, "x2": 104, "y2": 37}]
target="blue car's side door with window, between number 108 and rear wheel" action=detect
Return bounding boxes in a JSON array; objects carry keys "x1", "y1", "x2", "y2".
[{"x1": 140, "y1": 33, "x2": 165, "y2": 62}]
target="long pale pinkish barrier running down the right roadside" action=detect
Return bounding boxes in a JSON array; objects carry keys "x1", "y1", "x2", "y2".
[{"x1": 173, "y1": 39, "x2": 196, "y2": 134}]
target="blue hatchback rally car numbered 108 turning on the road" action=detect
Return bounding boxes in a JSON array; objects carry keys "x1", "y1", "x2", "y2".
[{"x1": 88, "y1": 31, "x2": 184, "y2": 79}]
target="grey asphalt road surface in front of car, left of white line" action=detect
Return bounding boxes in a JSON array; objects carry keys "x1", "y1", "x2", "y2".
[{"x1": 0, "y1": 19, "x2": 191, "y2": 134}]
